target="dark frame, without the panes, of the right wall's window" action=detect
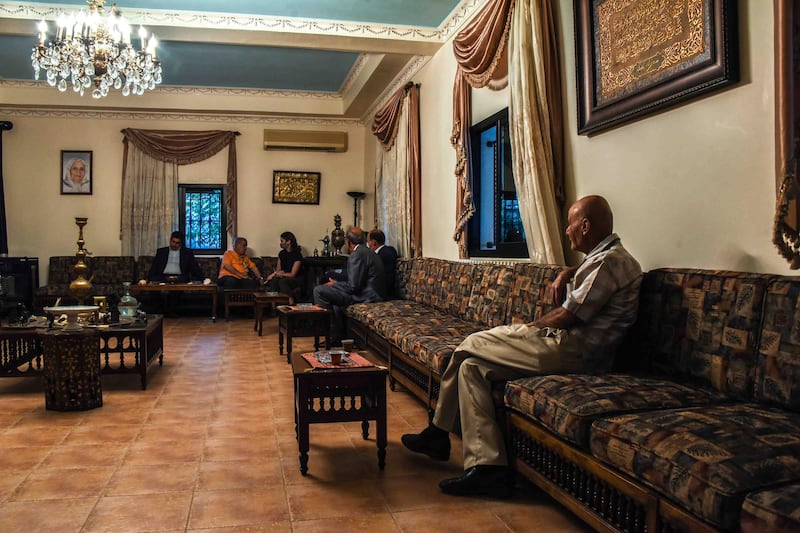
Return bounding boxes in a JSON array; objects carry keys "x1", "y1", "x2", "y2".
[{"x1": 467, "y1": 107, "x2": 529, "y2": 259}]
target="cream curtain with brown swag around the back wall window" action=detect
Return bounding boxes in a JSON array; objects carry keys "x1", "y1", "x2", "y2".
[{"x1": 120, "y1": 128, "x2": 239, "y2": 257}]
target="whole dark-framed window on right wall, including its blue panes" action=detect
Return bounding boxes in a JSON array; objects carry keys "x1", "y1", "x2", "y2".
[{"x1": 468, "y1": 108, "x2": 528, "y2": 257}]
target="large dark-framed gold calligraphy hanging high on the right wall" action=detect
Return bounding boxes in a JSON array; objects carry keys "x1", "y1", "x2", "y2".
[{"x1": 574, "y1": 0, "x2": 739, "y2": 134}]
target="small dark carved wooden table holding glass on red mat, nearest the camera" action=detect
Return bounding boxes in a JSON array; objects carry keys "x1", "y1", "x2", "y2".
[{"x1": 291, "y1": 352, "x2": 389, "y2": 475}]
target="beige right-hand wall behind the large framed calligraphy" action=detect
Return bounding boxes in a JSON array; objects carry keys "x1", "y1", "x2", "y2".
[{"x1": 404, "y1": 0, "x2": 791, "y2": 273}]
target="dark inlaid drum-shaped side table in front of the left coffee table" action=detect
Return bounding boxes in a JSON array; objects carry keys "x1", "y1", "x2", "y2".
[{"x1": 41, "y1": 329, "x2": 103, "y2": 411}]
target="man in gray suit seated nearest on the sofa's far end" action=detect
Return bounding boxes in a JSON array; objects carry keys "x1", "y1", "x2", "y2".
[{"x1": 314, "y1": 226, "x2": 386, "y2": 347}]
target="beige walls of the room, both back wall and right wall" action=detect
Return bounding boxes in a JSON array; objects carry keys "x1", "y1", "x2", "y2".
[{"x1": 3, "y1": 0, "x2": 792, "y2": 282}]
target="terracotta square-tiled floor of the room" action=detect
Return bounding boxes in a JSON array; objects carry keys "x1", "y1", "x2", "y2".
[{"x1": 0, "y1": 318, "x2": 587, "y2": 533}]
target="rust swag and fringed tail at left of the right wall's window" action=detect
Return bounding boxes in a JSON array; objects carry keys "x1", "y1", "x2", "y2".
[{"x1": 450, "y1": 0, "x2": 514, "y2": 258}]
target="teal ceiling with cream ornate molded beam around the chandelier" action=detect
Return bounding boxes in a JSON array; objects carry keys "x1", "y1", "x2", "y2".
[{"x1": 0, "y1": 0, "x2": 466, "y2": 112}]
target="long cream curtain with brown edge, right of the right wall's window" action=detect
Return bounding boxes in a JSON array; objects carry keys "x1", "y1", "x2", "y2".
[{"x1": 509, "y1": 0, "x2": 564, "y2": 265}]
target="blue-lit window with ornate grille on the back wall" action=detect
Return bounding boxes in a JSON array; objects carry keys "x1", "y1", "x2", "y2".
[{"x1": 178, "y1": 185, "x2": 223, "y2": 255}]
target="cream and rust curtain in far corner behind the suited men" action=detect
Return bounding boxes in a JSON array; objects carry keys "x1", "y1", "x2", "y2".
[{"x1": 372, "y1": 82, "x2": 422, "y2": 257}]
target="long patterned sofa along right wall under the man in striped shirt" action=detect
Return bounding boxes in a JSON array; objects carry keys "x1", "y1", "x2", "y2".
[{"x1": 347, "y1": 258, "x2": 800, "y2": 532}]
